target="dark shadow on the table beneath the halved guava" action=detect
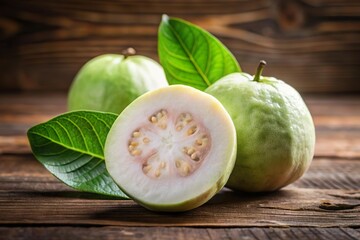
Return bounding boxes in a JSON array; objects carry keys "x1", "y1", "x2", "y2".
[{"x1": 87, "y1": 189, "x2": 291, "y2": 226}]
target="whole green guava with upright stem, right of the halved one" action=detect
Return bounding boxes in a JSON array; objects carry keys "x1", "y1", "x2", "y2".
[{"x1": 205, "y1": 61, "x2": 315, "y2": 192}]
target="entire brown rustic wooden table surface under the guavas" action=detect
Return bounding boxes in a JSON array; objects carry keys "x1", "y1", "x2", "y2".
[{"x1": 0, "y1": 94, "x2": 360, "y2": 240}]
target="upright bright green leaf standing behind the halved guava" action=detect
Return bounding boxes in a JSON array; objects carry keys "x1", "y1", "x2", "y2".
[{"x1": 158, "y1": 15, "x2": 241, "y2": 90}]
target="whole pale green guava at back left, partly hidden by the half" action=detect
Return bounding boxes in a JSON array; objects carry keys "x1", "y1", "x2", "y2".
[{"x1": 68, "y1": 48, "x2": 168, "y2": 113}]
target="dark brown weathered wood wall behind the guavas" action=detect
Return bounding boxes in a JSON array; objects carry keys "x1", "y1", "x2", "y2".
[{"x1": 0, "y1": 0, "x2": 360, "y2": 92}]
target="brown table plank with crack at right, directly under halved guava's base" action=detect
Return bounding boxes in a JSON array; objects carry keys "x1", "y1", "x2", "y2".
[{"x1": 0, "y1": 188, "x2": 360, "y2": 228}]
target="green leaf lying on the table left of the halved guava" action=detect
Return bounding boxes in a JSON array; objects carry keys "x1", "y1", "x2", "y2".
[{"x1": 28, "y1": 111, "x2": 128, "y2": 199}]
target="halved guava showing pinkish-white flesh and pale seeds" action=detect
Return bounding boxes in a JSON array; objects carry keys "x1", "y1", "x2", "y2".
[{"x1": 104, "y1": 85, "x2": 236, "y2": 211}]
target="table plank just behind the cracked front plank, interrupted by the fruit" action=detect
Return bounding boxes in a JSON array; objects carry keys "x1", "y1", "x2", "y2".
[{"x1": 0, "y1": 155, "x2": 360, "y2": 192}]
